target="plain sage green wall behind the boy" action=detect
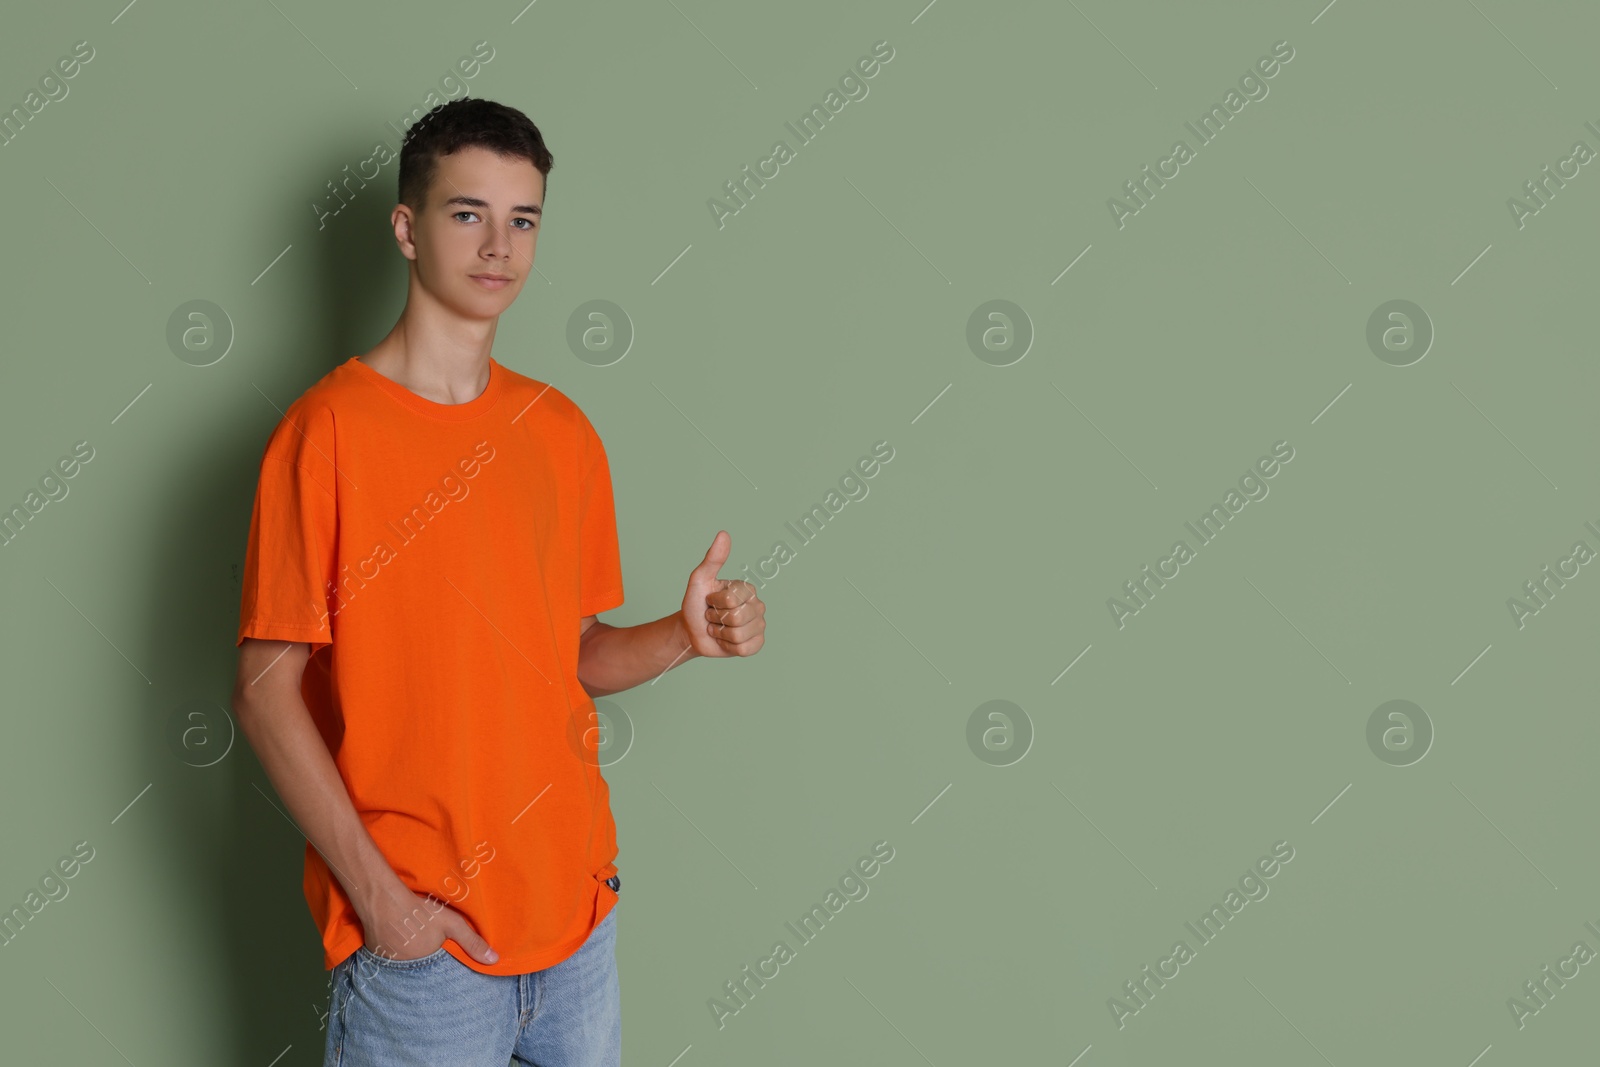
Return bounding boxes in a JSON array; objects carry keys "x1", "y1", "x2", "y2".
[{"x1": 0, "y1": 0, "x2": 1600, "y2": 1067}]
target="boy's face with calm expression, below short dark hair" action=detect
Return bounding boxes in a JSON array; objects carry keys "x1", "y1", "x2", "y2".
[{"x1": 394, "y1": 147, "x2": 544, "y2": 318}]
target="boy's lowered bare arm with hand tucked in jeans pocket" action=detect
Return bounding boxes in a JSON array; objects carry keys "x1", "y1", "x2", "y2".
[{"x1": 234, "y1": 638, "x2": 499, "y2": 963}]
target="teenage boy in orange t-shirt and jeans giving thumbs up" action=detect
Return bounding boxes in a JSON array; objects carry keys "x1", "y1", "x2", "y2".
[{"x1": 234, "y1": 98, "x2": 766, "y2": 1067}]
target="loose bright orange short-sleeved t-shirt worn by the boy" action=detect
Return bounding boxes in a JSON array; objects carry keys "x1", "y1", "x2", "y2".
[{"x1": 235, "y1": 357, "x2": 622, "y2": 974}]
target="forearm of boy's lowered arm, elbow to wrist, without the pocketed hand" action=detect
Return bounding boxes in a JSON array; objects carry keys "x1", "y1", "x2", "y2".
[{"x1": 234, "y1": 689, "x2": 400, "y2": 921}]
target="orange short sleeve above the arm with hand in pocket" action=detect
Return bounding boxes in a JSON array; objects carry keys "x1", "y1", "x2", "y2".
[{"x1": 234, "y1": 406, "x2": 339, "y2": 653}]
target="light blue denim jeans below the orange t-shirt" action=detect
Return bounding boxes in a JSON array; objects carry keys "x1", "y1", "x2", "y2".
[{"x1": 323, "y1": 905, "x2": 622, "y2": 1067}]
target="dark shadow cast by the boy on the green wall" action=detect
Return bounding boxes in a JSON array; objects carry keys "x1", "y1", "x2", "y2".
[{"x1": 145, "y1": 130, "x2": 408, "y2": 1067}]
